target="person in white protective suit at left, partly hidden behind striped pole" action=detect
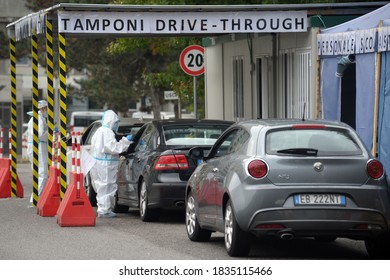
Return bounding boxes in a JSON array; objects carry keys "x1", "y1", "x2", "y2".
[{"x1": 27, "y1": 100, "x2": 48, "y2": 202}]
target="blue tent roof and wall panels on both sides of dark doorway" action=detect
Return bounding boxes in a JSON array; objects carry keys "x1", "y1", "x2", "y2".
[{"x1": 320, "y1": 4, "x2": 390, "y2": 150}]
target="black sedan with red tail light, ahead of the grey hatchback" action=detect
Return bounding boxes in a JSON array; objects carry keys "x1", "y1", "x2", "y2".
[{"x1": 114, "y1": 119, "x2": 233, "y2": 222}]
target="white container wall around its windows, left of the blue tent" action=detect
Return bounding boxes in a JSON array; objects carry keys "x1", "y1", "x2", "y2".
[{"x1": 205, "y1": 29, "x2": 316, "y2": 121}]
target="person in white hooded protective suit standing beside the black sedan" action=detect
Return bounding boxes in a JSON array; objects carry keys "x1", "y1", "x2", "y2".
[{"x1": 90, "y1": 110, "x2": 132, "y2": 218}]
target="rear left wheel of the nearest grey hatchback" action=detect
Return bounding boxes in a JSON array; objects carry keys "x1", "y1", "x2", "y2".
[{"x1": 225, "y1": 200, "x2": 252, "y2": 257}]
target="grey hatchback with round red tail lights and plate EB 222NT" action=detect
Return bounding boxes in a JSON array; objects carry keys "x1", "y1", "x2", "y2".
[{"x1": 186, "y1": 120, "x2": 390, "y2": 258}]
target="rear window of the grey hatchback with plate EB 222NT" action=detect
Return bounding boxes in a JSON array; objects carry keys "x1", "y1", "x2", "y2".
[{"x1": 266, "y1": 128, "x2": 362, "y2": 156}]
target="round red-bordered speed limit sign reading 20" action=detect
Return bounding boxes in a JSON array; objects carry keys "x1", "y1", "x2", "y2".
[{"x1": 180, "y1": 45, "x2": 204, "y2": 76}]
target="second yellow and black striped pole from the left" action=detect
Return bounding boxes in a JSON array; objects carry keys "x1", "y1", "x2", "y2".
[{"x1": 31, "y1": 34, "x2": 39, "y2": 206}]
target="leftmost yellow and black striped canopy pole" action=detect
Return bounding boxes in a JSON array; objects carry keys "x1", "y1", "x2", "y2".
[{"x1": 9, "y1": 39, "x2": 17, "y2": 197}]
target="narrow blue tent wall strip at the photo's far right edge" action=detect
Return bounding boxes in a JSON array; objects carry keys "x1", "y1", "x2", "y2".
[{"x1": 378, "y1": 52, "x2": 390, "y2": 174}]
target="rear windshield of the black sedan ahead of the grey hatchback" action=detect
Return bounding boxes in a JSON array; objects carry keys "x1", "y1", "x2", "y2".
[{"x1": 163, "y1": 124, "x2": 228, "y2": 146}]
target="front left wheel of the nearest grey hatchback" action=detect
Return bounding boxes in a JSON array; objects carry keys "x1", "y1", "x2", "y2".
[{"x1": 186, "y1": 193, "x2": 211, "y2": 241}]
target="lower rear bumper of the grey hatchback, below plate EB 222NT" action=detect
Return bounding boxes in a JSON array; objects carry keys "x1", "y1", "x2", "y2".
[{"x1": 249, "y1": 207, "x2": 389, "y2": 238}]
